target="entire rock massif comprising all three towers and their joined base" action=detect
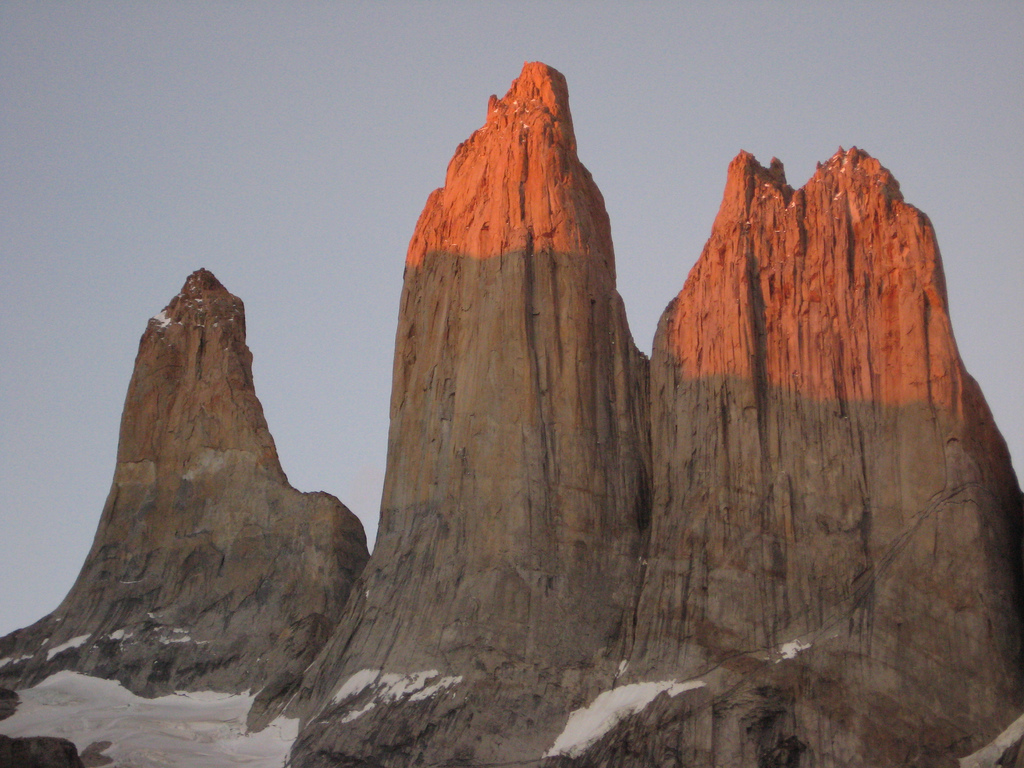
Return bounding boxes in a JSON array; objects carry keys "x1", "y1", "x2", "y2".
[{"x1": 0, "y1": 63, "x2": 1024, "y2": 768}]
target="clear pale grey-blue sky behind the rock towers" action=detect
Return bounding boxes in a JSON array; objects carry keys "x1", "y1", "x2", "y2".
[{"x1": 0, "y1": 0, "x2": 1024, "y2": 633}]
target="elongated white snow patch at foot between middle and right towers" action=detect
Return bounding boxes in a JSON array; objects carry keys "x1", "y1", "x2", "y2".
[{"x1": 544, "y1": 680, "x2": 705, "y2": 758}]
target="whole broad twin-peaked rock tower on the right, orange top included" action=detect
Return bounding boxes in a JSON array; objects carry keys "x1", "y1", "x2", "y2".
[{"x1": 563, "y1": 150, "x2": 1024, "y2": 768}]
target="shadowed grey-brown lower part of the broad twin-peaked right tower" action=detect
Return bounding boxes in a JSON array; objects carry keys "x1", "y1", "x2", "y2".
[{"x1": 555, "y1": 378, "x2": 1022, "y2": 768}]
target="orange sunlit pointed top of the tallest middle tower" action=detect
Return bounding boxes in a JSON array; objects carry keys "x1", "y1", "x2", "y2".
[{"x1": 406, "y1": 63, "x2": 614, "y2": 274}]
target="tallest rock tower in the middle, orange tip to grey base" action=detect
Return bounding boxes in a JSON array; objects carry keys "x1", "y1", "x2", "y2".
[{"x1": 295, "y1": 63, "x2": 649, "y2": 766}]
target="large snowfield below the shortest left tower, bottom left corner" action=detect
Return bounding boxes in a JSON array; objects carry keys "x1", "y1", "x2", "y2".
[{"x1": 0, "y1": 671, "x2": 298, "y2": 768}]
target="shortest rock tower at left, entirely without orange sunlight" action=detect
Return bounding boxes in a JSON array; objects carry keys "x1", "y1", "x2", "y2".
[{"x1": 0, "y1": 269, "x2": 368, "y2": 695}]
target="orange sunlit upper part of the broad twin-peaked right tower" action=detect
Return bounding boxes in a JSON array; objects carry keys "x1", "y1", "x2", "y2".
[{"x1": 671, "y1": 147, "x2": 966, "y2": 407}]
